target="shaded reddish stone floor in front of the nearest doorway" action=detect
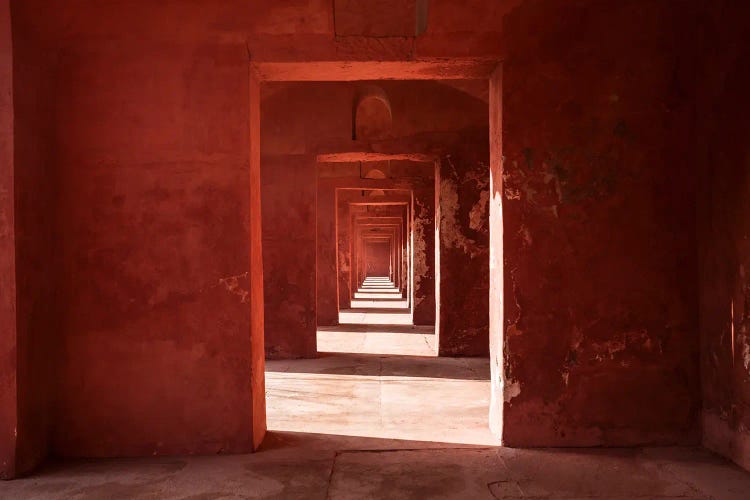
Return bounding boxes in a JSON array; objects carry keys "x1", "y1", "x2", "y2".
[{"x1": 0, "y1": 450, "x2": 750, "y2": 500}]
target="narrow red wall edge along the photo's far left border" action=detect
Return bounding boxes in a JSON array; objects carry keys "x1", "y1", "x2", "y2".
[{"x1": 0, "y1": 0, "x2": 17, "y2": 479}]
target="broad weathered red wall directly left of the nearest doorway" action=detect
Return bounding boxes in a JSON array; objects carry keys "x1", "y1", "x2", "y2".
[{"x1": 52, "y1": 40, "x2": 253, "y2": 456}]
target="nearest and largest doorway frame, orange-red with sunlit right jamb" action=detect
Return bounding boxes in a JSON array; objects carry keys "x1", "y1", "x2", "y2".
[{"x1": 247, "y1": 59, "x2": 505, "y2": 449}]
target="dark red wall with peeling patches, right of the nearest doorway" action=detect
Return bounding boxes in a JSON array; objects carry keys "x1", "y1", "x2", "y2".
[{"x1": 503, "y1": 0, "x2": 700, "y2": 446}]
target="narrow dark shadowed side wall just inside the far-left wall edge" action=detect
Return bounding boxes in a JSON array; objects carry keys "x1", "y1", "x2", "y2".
[{"x1": 12, "y1": 1, "x2": 61, "y2": 473}]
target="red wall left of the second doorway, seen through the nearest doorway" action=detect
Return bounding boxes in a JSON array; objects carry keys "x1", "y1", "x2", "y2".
[{"x1": 261, "y1": 83, "x2": 317, "y2": 358}]
